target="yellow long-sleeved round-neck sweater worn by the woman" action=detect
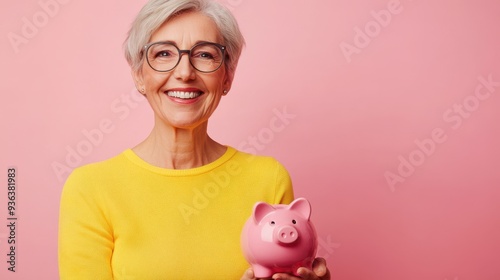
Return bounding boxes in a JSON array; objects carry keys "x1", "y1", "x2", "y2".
[{"x1": 59, "y1": 147, "x2": 293, "y2": 280}]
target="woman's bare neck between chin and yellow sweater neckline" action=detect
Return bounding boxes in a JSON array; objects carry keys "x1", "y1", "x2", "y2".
[{"x1": 132, "y1": 118, "x2": 226, "y2": 169}]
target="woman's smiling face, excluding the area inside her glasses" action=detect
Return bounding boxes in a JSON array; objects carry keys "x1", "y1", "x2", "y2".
[{"x1": 133, "y1": 12, "x2": 231, "y2": 129}]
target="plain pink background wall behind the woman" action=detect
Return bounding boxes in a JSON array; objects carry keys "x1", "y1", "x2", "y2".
[{"x1": 0, "y1": 0, "x2": 500, "y2": 280}]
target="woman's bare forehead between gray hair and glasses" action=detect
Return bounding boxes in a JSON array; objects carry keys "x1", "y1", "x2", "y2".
[{"x1": 151, "y1": 12, "x2": 222, "y2": 44}]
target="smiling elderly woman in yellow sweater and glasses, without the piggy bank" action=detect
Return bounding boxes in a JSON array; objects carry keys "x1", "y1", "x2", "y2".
[{"x1": 59, "y1": 0, "x2": 330, "y2": 280}]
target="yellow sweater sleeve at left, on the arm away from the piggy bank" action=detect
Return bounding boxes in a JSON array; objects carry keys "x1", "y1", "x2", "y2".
[{"x1": 58, "y1": 169, "x2": 114, "y2": 280}]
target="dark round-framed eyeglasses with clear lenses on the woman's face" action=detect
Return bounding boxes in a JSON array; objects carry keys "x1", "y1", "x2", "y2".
[{"x1": 144, "y1": 42, "x2": 226, "y2": 73}]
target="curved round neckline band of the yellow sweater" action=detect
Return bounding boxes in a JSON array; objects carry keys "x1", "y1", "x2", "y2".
[{"x1": 123, "y1": 146, "x2": 237, "y2": 176}]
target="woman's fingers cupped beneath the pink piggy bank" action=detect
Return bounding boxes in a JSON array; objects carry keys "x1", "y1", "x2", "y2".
[{"x1": 241, "y1": 258, "x2": 330, "y2": 280}]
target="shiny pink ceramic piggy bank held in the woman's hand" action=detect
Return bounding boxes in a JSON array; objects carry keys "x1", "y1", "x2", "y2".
[{"x1": 241, "y1": 198, "x2": 318, "y2": 278}]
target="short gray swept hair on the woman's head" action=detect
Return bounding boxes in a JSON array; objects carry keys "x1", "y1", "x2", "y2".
[{"x1": 123, "y1": 0, "x2": 245, "y2": 80}]
